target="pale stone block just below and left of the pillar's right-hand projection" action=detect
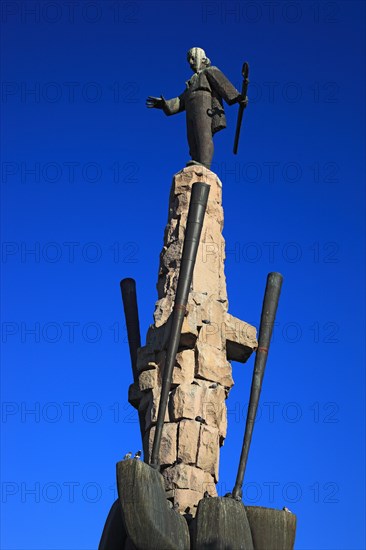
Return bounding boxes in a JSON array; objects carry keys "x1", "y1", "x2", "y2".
[{"x1": 196, "y1": 341, "x2": 234, "y2": 388}]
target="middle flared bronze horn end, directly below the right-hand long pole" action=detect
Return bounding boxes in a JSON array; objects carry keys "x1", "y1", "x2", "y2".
[{"x1": 191, "y1": 497, "x2": 254, "y2": 550}]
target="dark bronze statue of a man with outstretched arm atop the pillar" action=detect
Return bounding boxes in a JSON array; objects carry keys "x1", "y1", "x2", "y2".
[{"x1": 146, "y1": 48, "x2": 248, "y2": 168}]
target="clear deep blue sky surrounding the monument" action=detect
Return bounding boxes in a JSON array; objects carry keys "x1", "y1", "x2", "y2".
[{"x1": 1, "y1": 0, "x2": 366, "y2": 550}]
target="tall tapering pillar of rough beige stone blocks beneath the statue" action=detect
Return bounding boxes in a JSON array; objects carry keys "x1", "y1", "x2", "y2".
[{"x1": 129, "y1": 165, "x2": 257, "y2": 516}]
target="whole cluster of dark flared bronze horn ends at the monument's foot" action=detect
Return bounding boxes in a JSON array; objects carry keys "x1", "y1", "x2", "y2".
[{"x1": 99, "y1": 459, "x2": 296, "y2": 550}]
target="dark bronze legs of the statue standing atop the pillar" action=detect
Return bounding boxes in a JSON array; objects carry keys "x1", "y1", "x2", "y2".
[{"x1": 186, "y1": 90, "x2": 214, "y2": 168}]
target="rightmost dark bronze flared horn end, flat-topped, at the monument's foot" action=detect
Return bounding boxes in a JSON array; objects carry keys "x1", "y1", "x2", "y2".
[{"x1": 245, "y1": 506, "x2": 296, "y2": 550}]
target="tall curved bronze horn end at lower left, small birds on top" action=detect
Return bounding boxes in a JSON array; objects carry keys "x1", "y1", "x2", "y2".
[{"x1": 117, "y1": 459, "x2": 190, "y2": 550}]
